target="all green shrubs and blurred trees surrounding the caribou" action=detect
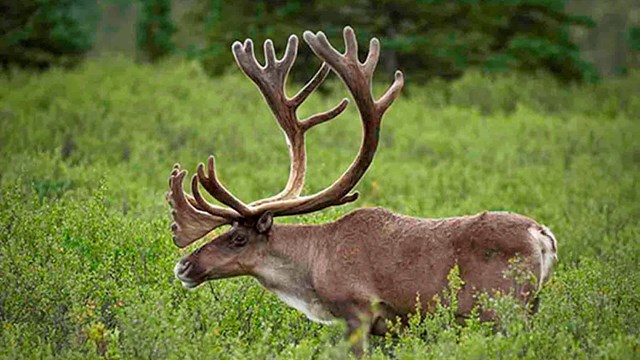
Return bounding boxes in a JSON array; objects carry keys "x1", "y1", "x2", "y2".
[{"x1": 0, "y1": 0, "x2": 640, "y2": 360}]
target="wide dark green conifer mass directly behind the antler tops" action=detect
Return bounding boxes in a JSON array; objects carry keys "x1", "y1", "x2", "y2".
[{"x1": 192, "y1": 0, "x2": 597, "y2": 81}]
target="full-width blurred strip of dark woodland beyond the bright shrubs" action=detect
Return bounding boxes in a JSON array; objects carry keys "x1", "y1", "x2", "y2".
[{"x1": 0, "y1": 0, "x2": 640, "y2": 83}]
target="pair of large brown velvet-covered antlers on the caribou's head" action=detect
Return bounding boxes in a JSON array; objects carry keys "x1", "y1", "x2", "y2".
[{"x1": 169, "y1": 27, "x2": 404, "y2": 247}]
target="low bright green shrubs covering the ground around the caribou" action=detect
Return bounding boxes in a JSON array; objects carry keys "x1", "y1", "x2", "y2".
[{"x1": 0, "y1": 58, "x2": 640, "y2": 359}]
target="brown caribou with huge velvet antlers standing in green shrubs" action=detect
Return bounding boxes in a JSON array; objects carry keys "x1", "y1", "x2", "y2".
[{"x1": 167, "y1": 27, "x2": 556, "y2": 354}]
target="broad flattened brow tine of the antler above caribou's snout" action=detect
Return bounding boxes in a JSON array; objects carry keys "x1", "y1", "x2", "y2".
[{"x1": 167, "y1": 166, "x2": 232, "y2": 248}]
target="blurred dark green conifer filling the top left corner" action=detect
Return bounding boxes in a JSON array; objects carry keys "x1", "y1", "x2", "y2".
[{"x1": 0, "y1": 0, "x2": 99, "y2": 69}]
